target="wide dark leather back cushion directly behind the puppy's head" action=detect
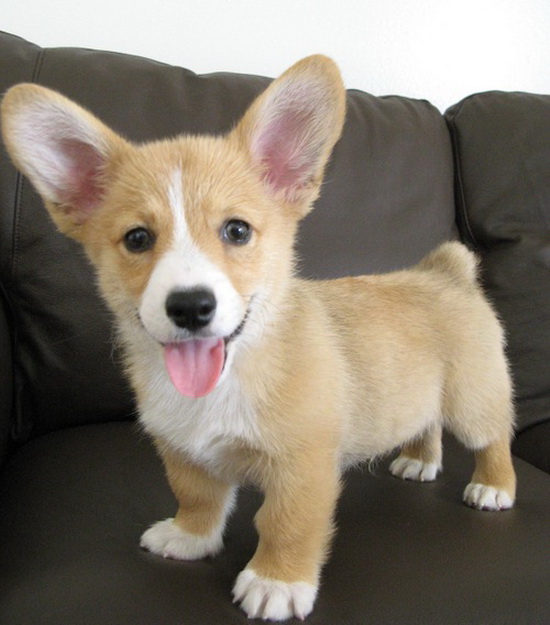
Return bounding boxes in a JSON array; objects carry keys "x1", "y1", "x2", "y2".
[{"x1": 0, "y1": 34, "x2": 456, "y2": 440}]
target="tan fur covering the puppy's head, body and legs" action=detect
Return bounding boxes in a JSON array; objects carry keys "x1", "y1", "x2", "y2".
[{"x1": 2, "y1": 57, "x2": 515, "y2": 618}]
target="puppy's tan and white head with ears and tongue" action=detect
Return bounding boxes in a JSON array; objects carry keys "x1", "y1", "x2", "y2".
[{"x1": 2, "y1": 56, "x2": 345, "y2": 396}]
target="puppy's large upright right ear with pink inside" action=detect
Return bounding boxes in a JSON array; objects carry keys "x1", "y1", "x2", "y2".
[{"x1": 235, "y1": 55, "x2": 345, "y2": 215}]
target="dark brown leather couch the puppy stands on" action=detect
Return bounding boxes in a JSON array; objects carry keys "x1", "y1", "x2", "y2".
[{"x1": 0, "y1": 33, "x2": 550, "y2": 625}]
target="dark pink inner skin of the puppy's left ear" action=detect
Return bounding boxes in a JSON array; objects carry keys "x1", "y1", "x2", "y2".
[{"x1": 58, "y1": 139, "x2": 105, "y2": 224}]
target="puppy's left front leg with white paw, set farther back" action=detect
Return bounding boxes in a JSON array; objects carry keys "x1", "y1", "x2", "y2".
[{"x1": 140, "y1": 445, "x2": 235, "y2": 560}]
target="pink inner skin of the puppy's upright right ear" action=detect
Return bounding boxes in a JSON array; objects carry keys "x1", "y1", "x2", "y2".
[{"x1": 253, "y1": 108, "x2": 320, "y2": 201}]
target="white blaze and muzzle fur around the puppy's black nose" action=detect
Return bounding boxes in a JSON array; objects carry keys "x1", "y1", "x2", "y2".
[{"x1": 139, "y1": 170, "x2": 246, "y2": 343}]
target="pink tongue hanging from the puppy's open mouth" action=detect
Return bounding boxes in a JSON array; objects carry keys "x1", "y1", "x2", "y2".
[{"x1": 164, "y1": 338, "x2": 225, "y2": 397}]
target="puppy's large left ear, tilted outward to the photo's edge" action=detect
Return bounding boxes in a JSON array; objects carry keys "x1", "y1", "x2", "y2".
[{"x1": 2, "y1": 84, "x2": 125, "y2": 237}]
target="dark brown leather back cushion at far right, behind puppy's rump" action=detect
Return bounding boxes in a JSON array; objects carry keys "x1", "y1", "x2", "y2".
[{"x1": 446, "y1": 92, "x2": 550, "y2": 430}]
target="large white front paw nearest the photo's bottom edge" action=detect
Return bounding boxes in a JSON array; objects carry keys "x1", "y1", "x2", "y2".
[{"x1": 233, "y1": 568, "x2": 317, "y2": 621}]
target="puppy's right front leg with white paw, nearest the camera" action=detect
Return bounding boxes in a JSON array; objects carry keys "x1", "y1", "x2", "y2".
[{"x1": 233, "y1": 454, "x2": 340, "y2": 621}]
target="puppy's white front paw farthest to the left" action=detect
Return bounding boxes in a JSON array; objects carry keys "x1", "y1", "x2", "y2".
[{"x1": 139, "y1": 519, "x2": 223, "y2": 560}]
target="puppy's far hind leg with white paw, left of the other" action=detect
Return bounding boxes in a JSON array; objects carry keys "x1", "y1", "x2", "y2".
[{"x1": 390, "y1": 425, "x2": 441, "y2": 482}]
